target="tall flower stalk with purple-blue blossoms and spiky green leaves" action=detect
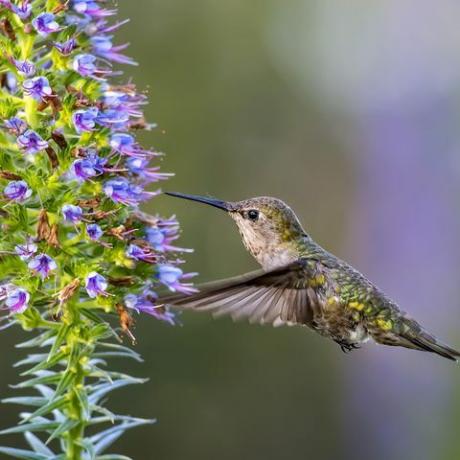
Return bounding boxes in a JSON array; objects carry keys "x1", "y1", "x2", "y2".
[{"x1": 0, "y1": 0, "x2": 193, "y2": 460}]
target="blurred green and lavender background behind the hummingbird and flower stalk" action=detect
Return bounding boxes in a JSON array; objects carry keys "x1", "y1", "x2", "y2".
[{"x1": 0, "y1": 0, "x2": 460, "y2": 460}]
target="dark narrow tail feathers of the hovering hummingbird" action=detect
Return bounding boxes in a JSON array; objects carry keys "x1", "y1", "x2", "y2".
[{"x1": 394, "y1": 318, "x2": 460, "y2": 361}]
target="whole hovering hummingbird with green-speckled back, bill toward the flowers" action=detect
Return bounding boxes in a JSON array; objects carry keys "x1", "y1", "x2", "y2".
[{"x1": 159, "y1": 192, "x2": 460, "y2": 361}]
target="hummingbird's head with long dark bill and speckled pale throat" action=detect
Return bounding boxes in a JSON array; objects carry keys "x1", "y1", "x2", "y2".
[{"x1": 166, "y1": 192, "x2": 306, "y2": 269}]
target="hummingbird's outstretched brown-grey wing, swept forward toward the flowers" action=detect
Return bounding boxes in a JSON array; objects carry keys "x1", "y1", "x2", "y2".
[{"x1": 158, "y1": 261, "x2": 321, "y2": 326}]
